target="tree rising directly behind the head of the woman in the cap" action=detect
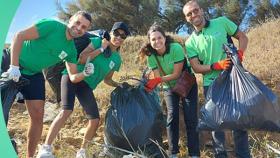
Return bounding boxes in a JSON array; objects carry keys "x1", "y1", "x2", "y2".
[{"x1": 57, "y1": 0, "x2": 161, "y2": 34}]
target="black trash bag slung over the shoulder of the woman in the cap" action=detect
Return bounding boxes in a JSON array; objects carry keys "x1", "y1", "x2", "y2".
[{"x1": 43, "y1": 29, "x2": 111, "y2": 103}]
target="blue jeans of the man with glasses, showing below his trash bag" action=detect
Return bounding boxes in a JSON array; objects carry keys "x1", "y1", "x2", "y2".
[{"x1": 203, "y1": 86, "x2": 251, "y2": 158}]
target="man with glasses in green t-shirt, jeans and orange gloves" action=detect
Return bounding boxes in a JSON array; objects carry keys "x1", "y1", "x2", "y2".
[{"x1": 183, "y1": 0, "x2": 250, "y2": 158}]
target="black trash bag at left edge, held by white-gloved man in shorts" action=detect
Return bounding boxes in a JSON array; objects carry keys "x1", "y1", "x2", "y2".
[{"x1": 0, "y1": 77, "x2": 29, "y2": 125}]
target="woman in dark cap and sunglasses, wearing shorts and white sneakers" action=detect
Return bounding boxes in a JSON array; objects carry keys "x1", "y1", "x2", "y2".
[{"x1": 39, "y1": 22, "x2": 130, "y2": 158}]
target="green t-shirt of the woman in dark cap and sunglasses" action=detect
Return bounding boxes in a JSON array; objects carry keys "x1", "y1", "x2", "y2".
[{"x1": 75, "y1": 37, "x2": 122, "y2": 90}]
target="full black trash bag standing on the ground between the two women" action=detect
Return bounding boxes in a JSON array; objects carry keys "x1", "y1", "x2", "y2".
[{"x1": 104, "y1": 84, "x2": 164, "y2": 158}]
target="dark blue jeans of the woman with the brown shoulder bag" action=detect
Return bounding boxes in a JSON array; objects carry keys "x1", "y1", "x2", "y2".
[{"x1": 164, "y1": 84, "x2": 200, "y2": 156}]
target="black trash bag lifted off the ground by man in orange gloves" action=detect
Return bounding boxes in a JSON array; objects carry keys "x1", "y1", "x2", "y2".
[{"x1": 198, "y1": 43, "x2": 280, "y2": 132}]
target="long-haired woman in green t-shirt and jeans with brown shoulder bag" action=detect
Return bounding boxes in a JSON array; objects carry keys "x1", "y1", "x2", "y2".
[{"x1": 141, "y1": 25, "x2": 200, "y2": 158}]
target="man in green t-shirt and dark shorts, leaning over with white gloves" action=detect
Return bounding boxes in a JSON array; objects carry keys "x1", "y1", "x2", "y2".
[{"x1": 4, "y1": 11, "x2": 93, "y2": 158}]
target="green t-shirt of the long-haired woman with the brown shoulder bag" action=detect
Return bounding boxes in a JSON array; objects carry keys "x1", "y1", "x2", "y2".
[{"x1": 147, "y1": 43, "x2": 187, "y2": 89}]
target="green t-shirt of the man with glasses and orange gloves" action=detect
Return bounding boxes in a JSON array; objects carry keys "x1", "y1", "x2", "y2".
[{"x1": 185, "y1": 17, "x2": 238, "y2": 86}]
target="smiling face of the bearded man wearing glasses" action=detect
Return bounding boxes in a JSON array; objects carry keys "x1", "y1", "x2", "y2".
[{"x1": 183, "y1": 2, "x2": 204, "y2": 28}]
